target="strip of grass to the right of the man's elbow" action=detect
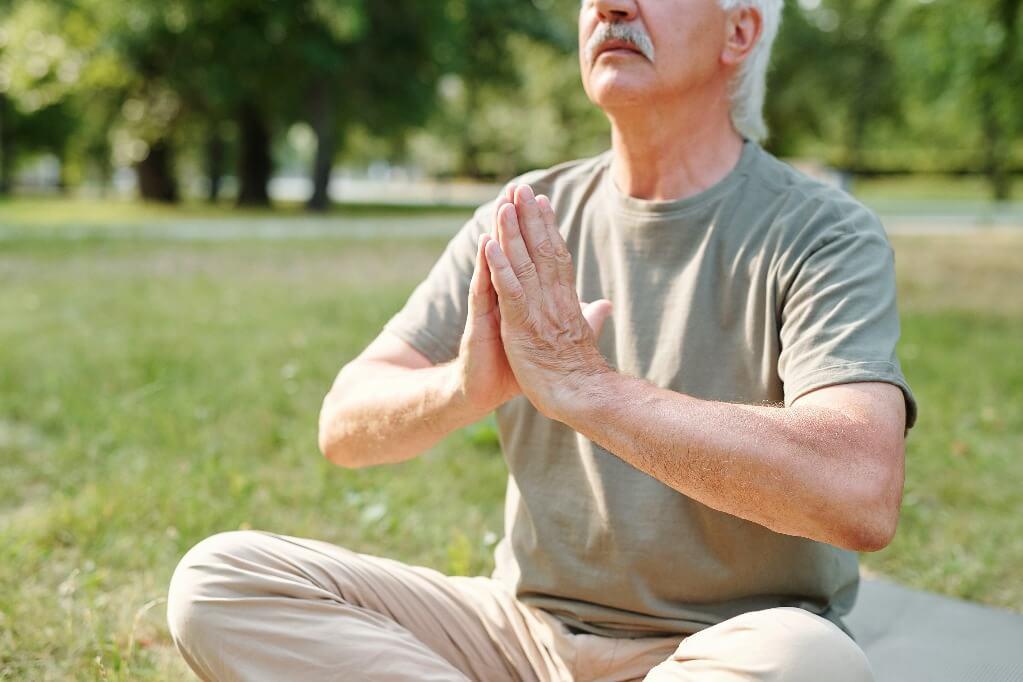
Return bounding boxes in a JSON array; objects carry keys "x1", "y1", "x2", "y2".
[{"x1": 863, "y1": 232, "x2": 1023, "y2": 611}]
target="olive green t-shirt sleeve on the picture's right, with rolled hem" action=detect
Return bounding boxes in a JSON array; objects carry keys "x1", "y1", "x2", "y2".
[{"x1": 777, "y1": 202, "x2": 917, "y2": 429}]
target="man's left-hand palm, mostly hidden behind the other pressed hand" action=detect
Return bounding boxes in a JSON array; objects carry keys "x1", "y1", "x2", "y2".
[{"x1": 453, "y1": 185, "x2": 607, "y2": 414}]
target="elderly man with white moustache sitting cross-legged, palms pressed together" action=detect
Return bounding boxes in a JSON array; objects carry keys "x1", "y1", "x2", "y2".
[{"x1": 168, "y1": 0, "x2": 916, "y2": 682}]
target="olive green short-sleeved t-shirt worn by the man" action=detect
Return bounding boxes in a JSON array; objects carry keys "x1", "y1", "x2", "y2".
[{"x1": 386, "y1": 140, "x2": 917, "y2": 637}]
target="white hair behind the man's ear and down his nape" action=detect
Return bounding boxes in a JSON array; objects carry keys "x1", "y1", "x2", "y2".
[{"x1": 718, "y1": 0, "x2": 784, "y2": 142}]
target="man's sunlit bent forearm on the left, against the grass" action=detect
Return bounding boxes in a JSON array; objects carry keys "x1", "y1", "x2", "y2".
[{"x1": 319, "y1": 362, "x2": 485, "y2": 467}]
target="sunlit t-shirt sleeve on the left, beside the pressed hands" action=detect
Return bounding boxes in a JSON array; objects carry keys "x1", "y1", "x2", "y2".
[{"x1": 384, "y1": 201, "x2": 496, "y2": 364}]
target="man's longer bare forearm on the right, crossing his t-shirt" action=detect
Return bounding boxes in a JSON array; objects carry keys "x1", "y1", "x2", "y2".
[{"x1": 558, "y1": 371, "x2": 901, "y2": 551}]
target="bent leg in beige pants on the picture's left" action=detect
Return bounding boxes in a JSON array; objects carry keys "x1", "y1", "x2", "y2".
[{"x1": 167, "y1": 531, "x2": 567, "y2": 682}]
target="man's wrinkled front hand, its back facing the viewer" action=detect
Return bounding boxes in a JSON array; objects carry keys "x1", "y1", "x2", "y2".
[{"x1": 481, "y1": 185, "x2": 613, "y2": 419}]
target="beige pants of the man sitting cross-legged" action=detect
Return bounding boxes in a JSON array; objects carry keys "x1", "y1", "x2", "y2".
[{"x1": 167, "y1": 531, "x2": 874, "y2": 682}]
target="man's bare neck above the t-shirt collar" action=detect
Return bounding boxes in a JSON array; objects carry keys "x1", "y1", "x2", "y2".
[{"x1": 608, "y1": 94, "x2": 743, "y2": 200}]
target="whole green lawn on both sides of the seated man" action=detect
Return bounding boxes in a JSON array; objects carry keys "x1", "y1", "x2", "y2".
[{"x1": 0, "y1": 222, "x2": 1023, "y2": 680}]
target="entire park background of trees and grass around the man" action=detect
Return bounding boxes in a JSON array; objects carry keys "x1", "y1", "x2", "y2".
[{"x1": 0, "y1": 0, "x2": 1023, "y2": 680}]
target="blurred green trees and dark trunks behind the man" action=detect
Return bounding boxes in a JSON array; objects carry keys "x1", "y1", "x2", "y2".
[{"x1": 0, "y1": 0, "x2": 1023, "y2": 202}]
